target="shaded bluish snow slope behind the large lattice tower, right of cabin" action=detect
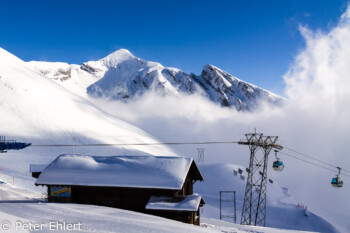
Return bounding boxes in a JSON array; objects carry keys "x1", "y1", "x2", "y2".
[{"x1": 194, "y1": 164, "x2": 338, "y2": 233}]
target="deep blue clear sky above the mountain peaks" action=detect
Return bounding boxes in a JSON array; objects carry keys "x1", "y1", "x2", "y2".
[{"x1": 0, "y1": 0, "x2": 348, "y2": 94}]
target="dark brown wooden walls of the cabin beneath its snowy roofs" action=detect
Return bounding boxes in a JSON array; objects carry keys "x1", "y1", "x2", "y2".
[{"x1": 48, "y1": 185, "x2": 200, "y2": 225}]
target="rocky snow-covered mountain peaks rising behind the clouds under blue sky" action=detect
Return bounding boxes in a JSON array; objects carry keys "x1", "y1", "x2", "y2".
[{"x1": 28, "y1": 49, "x2": 284, "y2": 110}]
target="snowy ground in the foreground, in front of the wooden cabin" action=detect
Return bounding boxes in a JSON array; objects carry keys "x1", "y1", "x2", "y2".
[{"x1": 0, "y1": 182, "x2": 316, "y2": 233}]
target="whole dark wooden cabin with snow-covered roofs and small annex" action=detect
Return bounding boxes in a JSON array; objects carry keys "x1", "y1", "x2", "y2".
[{"x1": 35, "y1": 155, "x2": 205, "y2": 225}]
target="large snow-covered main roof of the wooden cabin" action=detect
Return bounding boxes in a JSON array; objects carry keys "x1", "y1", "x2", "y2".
[{"x1": 35, "y1": 155, "x2": 203, "y2": 190}]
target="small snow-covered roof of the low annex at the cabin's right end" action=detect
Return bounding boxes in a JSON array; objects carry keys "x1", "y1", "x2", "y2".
[{"x1": 146, "y1": 193, "x2": 204, "y2": 211}]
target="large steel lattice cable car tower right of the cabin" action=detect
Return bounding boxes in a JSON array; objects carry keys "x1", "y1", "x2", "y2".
[{"x1": 238, "y1": 133, "x2": 283, "y2": 226}]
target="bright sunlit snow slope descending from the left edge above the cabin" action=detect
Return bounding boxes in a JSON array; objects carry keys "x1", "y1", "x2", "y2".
[{"x1": 0, "y1": 48, "x2": 174, "y2": 156}]
